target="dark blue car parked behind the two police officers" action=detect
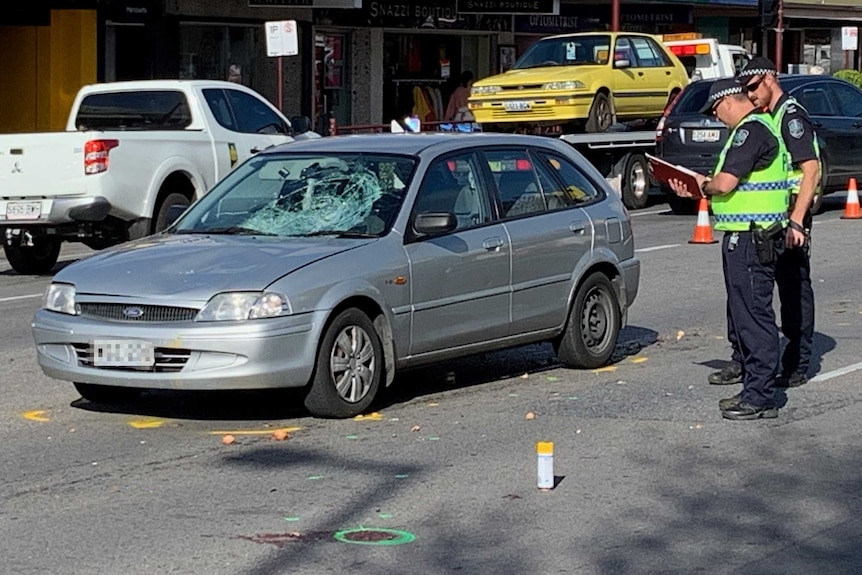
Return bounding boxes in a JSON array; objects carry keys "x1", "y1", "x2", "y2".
[{"x1": 656, "y1": 74, "x2": 862, "y2": 214}]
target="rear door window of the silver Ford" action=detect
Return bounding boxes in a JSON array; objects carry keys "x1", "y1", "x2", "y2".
[{"x1": 485, "y1": 150, "x2": 547, "y2": 218}]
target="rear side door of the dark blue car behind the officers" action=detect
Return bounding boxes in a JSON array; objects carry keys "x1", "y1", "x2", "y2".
[{"x1": 791, "y1": 82, "x2": 858, "y2": 188}]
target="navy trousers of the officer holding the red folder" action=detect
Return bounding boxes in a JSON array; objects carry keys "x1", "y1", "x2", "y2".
[{"x1": 721, "y1": 232, "x2": 784, "y2": 407}]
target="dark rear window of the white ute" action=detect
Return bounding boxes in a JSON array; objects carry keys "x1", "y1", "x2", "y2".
[{"x1": 75, "y1": 90, "x2": 192, "y2": 130}]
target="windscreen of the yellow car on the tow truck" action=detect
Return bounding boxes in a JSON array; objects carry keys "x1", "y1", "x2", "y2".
[{"x1": 512, "y1": 34, "x2": 611, "y2": 70}]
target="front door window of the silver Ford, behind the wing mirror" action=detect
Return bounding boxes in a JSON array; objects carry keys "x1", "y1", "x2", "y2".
[{"x1": 413, "y1": 152, "x2": 491, "y2": 234}]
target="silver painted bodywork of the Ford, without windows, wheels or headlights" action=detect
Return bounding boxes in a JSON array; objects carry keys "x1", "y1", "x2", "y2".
[{"x1": 33, "y1": 134, "x2": 640, "y2": 414}]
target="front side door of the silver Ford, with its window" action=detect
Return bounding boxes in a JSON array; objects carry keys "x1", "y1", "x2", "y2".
[{"x1": 405, "y1": 151, "x2": 510, "y2": 355}]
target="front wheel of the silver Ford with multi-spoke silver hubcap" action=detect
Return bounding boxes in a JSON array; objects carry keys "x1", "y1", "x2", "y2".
[{"x1": 305, "y1": 308, "x2": 385, "y2": 418}]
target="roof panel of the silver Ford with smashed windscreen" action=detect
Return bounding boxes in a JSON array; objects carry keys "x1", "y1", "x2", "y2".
[{"x1": 264, "y1": 132, "x2": 572, "y2": 156}]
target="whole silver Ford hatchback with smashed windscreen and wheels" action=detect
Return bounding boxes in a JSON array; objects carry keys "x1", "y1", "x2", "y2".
[{"x1": 33, "y1": 133, "x2": 640, "y2": 417}]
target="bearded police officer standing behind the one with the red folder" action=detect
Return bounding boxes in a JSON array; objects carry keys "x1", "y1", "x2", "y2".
[{"x1": 709, "y1": 57, "x2": 821, "y2": 387}]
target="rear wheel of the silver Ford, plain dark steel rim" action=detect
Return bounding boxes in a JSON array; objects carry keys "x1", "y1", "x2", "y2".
[{"x1": 556, "y1": 273, "x2": 621, "y2": 369}]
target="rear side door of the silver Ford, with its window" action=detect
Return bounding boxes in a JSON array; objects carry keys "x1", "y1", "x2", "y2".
[{"x1": 484, "y1": 147, "x2": 592, "y2": 335}]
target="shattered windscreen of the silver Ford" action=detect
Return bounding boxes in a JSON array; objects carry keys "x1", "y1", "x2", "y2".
[{"x1": 171, "y1": 153, "x2": 416, "y2": 237}]
